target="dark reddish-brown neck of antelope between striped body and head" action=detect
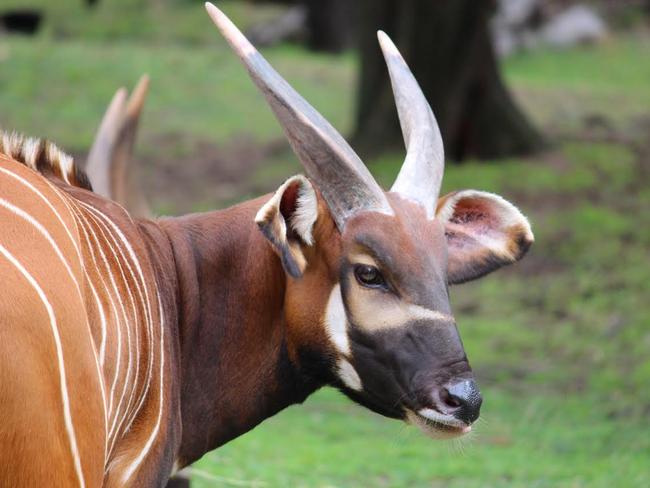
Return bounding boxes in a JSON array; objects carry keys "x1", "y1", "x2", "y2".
[{"x1": 146, "y1": 199, "x2": 320, "y2": 466}]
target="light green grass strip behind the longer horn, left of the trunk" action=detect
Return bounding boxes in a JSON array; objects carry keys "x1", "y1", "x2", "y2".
[{"x1": 0, "y1": 37, "x2": 354, "y2": 152}]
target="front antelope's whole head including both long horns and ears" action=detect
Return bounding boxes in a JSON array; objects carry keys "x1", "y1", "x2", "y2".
[{"x1": 206, "y1": 3, "x2": 533, "y2": 437}]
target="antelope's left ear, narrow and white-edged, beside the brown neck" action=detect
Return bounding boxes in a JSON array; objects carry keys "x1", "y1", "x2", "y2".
[{"x1": 255, "y1": 175, "x2": 318, "y2": 278}]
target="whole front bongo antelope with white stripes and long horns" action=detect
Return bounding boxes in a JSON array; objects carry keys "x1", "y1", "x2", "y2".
[{"x1": 0, "y1": 4, "x2": 533, "y2": 487}]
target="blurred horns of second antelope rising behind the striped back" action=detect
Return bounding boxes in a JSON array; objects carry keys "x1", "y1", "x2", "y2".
[{"x1": 86, "y1": 75, "x2": 151, "y2": 217}]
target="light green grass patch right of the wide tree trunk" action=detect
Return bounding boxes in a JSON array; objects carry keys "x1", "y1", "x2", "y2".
[{"x1": 505, "y1": 35, "x2": 650, "y2": 131}]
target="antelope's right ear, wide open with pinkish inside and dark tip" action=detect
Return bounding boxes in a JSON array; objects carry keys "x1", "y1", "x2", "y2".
[{"x1": 437, "y1": 190, "x2": 535, "y2": 284}]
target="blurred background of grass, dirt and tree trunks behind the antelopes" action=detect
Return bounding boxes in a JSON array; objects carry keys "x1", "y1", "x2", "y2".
[{"x1": 0, "y1": 0, "x2": 650, "y2": 487}]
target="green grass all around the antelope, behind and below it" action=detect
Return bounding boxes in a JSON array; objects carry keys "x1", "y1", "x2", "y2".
[{"x1": 0, "y1": 0, "x2": 650, "y2": 487}]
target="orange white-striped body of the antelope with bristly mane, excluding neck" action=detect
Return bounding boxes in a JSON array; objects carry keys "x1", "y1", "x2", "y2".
[{"x1": 0, "y1": 134, "x2": 173, "y2": 486}]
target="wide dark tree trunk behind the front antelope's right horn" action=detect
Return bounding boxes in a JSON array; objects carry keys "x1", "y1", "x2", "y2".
[{"x1": 354, "y1": 0, "x2": 543, "y2": 161}]
